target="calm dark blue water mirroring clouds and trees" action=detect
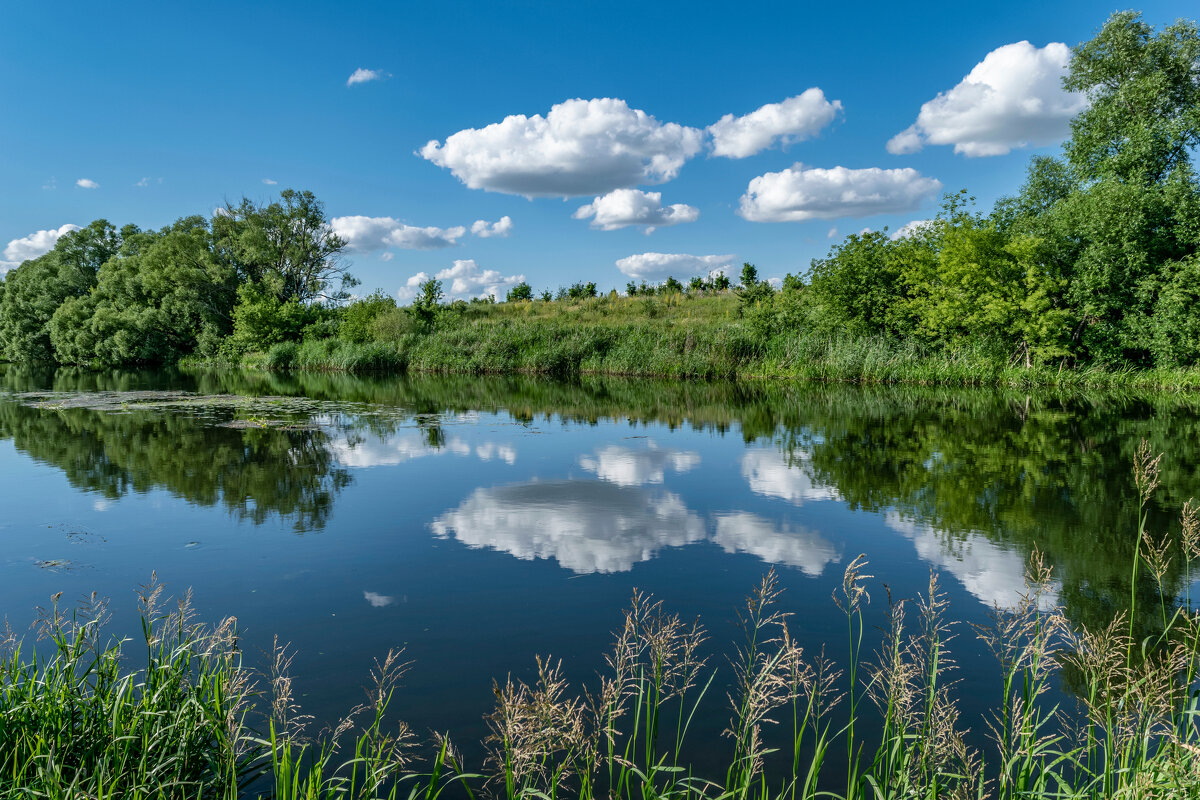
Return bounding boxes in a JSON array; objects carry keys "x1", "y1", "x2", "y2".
[{"x1": 0, "y1": 366, "x2": 1200, "y2": 777}]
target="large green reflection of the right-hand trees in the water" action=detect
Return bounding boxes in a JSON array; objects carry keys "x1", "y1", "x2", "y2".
[{"x1": 780, "y1": 392, "x2": 1200, "y2": 633}]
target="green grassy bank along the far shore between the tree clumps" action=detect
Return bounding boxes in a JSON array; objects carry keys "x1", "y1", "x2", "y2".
[{"x1": 206, "y1": 293, "x2": 1200, "y2": 391}]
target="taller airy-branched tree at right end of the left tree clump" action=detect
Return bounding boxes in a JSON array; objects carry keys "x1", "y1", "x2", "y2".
[{"x1": 212, "y1": 190, "x2": 358, "y2": 303}]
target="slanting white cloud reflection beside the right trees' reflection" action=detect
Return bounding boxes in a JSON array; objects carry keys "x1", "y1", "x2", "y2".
[{"x1": 883, "y1": 511, "x2": 1061, "y2": 609}]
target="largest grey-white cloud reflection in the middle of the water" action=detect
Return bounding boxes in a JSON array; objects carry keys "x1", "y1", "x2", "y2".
[{"x1": 432, "y1": 481, "x2": 704, "y2": 573}]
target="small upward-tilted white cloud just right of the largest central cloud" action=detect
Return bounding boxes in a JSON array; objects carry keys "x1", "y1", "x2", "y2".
[{"x1": 708, "y1": 86, "x2": 841, "y2": 158}]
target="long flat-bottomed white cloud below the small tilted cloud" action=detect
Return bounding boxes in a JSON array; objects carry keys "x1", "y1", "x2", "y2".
[{"x1": 738, "y1": 164, "x2": 942, "y2": 222}]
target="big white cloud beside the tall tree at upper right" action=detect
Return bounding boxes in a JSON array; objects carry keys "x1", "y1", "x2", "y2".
[{"x1": 888, "y1": 42, "x2": 1087, "y2": 156}]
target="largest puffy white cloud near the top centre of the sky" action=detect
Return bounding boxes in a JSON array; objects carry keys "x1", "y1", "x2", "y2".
[{"x1": 419, "y1": 97, "x2": 703, "y2": 197}]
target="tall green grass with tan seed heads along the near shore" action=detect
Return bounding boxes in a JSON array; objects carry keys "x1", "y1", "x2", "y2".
[{"x1": 7, "y1": 445, "x2": 1200, "y2": 800}]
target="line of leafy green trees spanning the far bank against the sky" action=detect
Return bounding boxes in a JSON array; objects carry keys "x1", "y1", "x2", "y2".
[{"x1": 0, "y1": 12, "x2": 1200, "y2": 368}]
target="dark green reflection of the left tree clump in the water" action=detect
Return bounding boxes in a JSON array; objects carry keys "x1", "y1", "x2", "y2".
[{"x1": 0, "y1": 402, "x2": 350, "y2": 531}]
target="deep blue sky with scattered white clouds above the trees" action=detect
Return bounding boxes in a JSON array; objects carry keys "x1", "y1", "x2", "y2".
[{"x1": 0, "y1": 0, "x2": 1198, "y2": 300}]
